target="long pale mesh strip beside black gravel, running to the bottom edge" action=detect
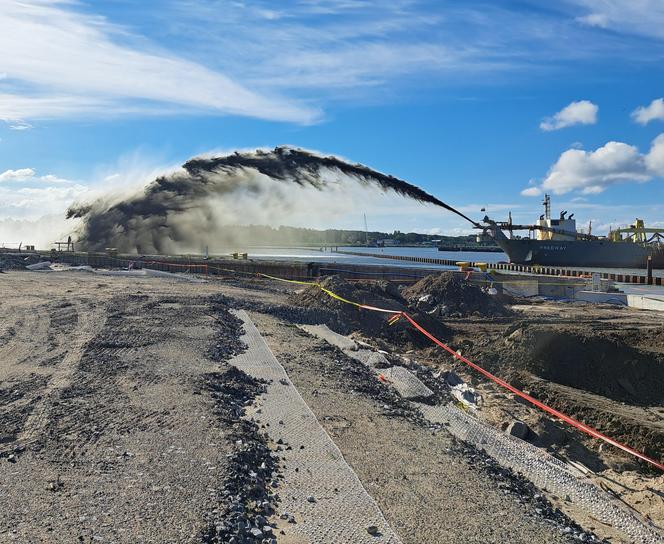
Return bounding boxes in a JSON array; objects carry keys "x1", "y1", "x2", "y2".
[{"x1": 230, "y1": 311, "x2": 401, "y2": 544}]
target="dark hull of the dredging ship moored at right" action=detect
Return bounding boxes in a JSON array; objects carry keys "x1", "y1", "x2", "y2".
[{"x1": 496, "y1": 236, "x2": 664, "y2": 268}]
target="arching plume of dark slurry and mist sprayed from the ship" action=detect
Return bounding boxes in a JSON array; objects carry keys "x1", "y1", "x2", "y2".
[{"x1": 67, "y1": 147, "x2": 476, "y2": 253}]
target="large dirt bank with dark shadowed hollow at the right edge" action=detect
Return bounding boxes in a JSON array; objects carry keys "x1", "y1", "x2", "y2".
[{"x1": 468, "y1": 321, "x2": 664, "y2": 462}]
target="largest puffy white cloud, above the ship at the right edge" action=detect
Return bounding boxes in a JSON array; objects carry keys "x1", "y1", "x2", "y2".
[{"x1": 521, "y1": 134, "x2": 664, "y2": 196}]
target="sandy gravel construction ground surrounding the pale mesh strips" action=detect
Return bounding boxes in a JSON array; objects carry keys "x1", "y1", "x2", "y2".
[{"x1": 0, "y1": 271, "x2": 664, "y2": 544}]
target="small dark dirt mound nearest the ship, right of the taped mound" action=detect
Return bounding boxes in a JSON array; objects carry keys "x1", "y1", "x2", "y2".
[{"x1": 403, "y1": 272, "x2": 510, "y2": 317}]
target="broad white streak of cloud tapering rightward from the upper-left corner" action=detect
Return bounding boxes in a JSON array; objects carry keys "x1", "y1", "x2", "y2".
[{"x1": 0, "y1": 0, "x2": 318, "y2": 127}]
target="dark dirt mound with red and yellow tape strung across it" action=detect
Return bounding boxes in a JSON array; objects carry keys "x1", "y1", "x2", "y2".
[{"x1": 289, "y1": 276, "x2": 449, "y2": 347}]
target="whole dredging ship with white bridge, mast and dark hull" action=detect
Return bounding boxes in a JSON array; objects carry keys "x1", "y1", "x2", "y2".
[{"x1": 478, "y1": 195, "x2": 664, "y2": 268}]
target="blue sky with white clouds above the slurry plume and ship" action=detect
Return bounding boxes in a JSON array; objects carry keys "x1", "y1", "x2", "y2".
[{"x1": 0, "y1": 0, "x2": 664, "y2": 244}]
